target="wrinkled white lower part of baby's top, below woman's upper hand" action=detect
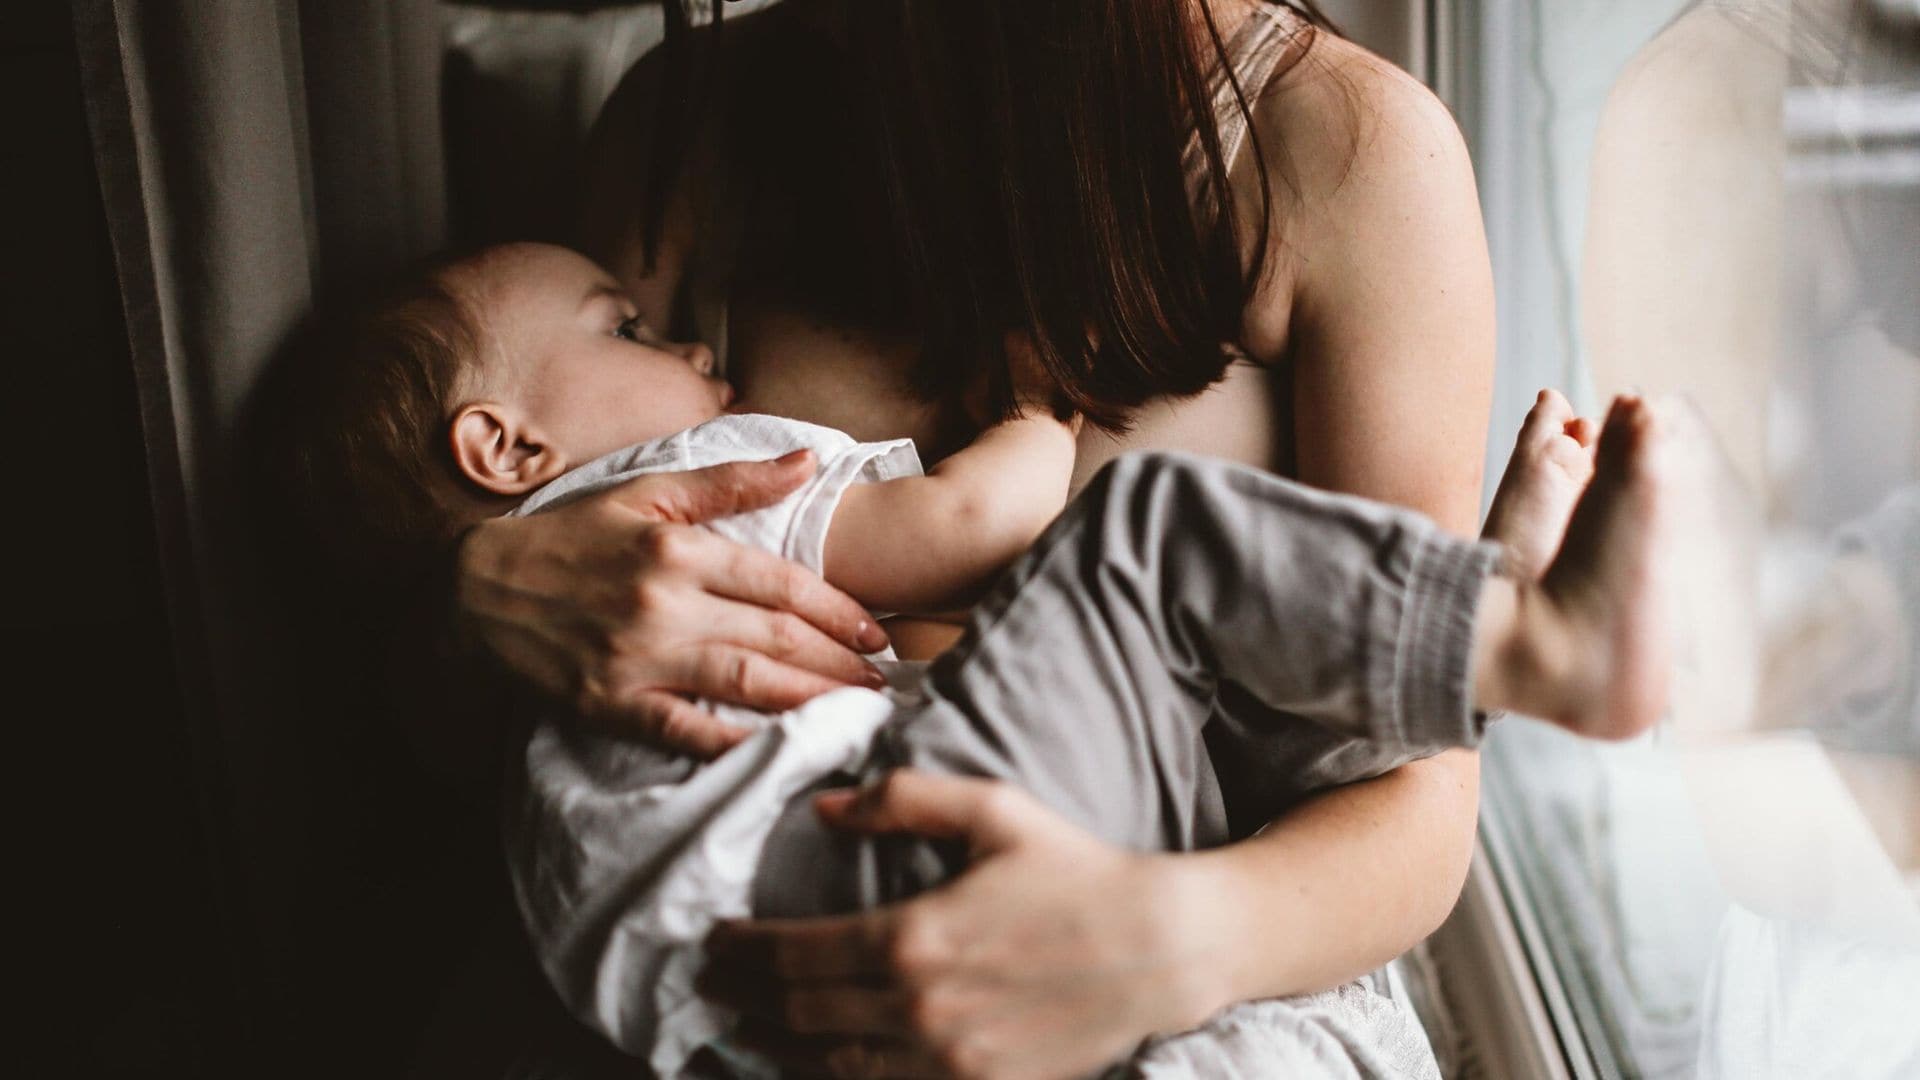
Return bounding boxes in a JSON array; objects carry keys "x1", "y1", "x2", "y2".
[{"x1": 509, "y1": 688, "x2": 893, "y2": 1076}]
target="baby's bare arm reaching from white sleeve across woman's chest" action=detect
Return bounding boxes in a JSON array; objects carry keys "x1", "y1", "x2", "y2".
[{"x1": 826, "y1": 407, "x2": 1073, "y2": 611}]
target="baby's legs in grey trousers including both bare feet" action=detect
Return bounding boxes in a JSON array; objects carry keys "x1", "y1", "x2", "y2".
[{"x1": 879, "y1": 394, "x2": 1711, "y2": 876}]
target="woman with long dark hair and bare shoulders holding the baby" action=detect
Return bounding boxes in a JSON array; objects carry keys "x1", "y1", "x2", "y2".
[{"x1": 457, "y1": 0, "x2": 1494, "y2": 1076}]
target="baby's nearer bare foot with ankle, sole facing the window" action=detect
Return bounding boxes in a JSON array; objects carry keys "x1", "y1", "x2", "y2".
[{"x1": 1521, "y1": 396, "x2": 1711, "y2": 738}]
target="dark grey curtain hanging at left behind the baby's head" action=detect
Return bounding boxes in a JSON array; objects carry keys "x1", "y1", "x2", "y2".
[{"x1": 73, "y1": 0, "x2": 478, "y2": 1076}]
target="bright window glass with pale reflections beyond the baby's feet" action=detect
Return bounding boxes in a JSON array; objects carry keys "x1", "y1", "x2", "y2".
[{"x1": 1442, "y1": 0, "x2": 1920, "y2": 1076}]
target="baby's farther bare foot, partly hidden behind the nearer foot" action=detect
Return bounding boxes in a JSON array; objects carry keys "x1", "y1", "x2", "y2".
[{"x1": 1480, "y1": 390, "x2": 1596, "y2": 582}]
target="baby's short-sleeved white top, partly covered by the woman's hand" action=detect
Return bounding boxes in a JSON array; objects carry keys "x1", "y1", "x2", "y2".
[{"x1": 507, "y1": 415, "x2": 922, "y2": 1078}]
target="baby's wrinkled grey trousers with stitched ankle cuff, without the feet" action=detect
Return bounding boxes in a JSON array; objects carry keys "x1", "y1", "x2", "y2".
[{"x1": 877, "y1": 455, "x2": 1498, "y2": 868}]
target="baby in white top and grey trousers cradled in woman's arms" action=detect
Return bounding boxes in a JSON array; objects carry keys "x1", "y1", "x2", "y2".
[{"x1": 284, "y1": 244, "x2": 1697, "y2": 1076}]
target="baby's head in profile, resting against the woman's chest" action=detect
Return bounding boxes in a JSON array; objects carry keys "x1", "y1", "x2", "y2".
[{"x1": 288, "y1": 244, "x2": 733, "y2": 569}]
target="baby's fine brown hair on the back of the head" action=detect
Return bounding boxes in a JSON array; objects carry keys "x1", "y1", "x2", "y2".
[{"x1": 267, "y1": 256, "x2": 482, "y2": 582}]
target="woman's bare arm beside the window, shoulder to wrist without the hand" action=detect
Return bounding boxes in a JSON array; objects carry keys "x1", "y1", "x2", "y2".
[{"x1": 1194, "y1": 37, "x2": 1494, "y2": 999}]
